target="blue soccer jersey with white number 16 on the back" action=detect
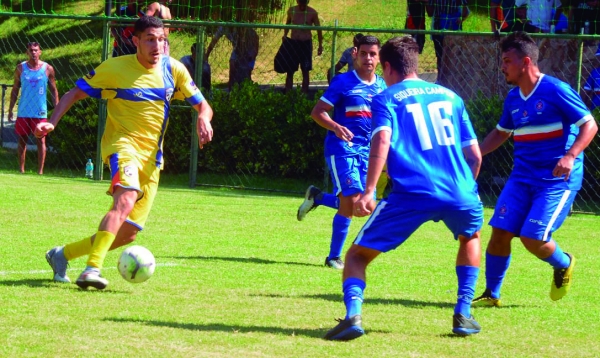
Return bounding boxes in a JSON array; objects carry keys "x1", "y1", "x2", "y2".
[{"x1": 371, "y1": 79, "x2": 481, "y2": 210}]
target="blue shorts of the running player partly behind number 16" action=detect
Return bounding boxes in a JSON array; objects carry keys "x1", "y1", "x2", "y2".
[{"x1": 325, "y1": 152, "x2": 369, "y2": 196}]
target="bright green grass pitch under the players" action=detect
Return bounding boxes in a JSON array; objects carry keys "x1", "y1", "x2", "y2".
[{"x1": 0, "y1": 174, "x2": 600, "y2": 357}]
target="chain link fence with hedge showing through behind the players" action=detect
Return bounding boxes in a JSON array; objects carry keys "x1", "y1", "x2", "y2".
[{"x1": 0, "y1": 13, "x2": 600, "y2": 213}]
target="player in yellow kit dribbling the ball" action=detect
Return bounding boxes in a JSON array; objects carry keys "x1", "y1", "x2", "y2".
[{"x1": 35, "y1": 16, "x2": 213, "y2": 289}]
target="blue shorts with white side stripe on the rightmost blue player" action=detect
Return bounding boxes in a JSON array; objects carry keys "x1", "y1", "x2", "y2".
[{"x1": 490, "y1": 180, "x2": 577, "y2": 242}]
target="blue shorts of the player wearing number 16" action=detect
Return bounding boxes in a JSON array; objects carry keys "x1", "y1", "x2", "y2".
[{"x1": 354, "y1": 199, "x2": 483, "y2": 252}]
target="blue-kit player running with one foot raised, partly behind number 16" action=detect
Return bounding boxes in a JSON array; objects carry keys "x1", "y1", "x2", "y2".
[{"x1": 297, "y1": 36, "x2": 386, "y2": 270}]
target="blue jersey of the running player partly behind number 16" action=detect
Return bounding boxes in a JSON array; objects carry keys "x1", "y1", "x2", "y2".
[{"x1": 321, "y1": 71, "x2": 386, "y2": 156}]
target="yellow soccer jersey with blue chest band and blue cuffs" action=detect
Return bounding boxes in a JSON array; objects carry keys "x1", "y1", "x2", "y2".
[{"x1": 76, "y1": 55, "x2": 204, "y2": 168}]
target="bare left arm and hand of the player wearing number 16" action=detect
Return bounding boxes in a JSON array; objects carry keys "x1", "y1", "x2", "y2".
[{"x1": 354, "y1": 130, "x2": 391, "y2": 217}]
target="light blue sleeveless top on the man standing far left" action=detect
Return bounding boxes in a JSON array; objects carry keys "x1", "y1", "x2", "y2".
[{"x1": 17, "y1": 61, "x2": 48, "y2": 118}]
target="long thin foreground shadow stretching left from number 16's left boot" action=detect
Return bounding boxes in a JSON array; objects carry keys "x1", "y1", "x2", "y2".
[{"x1": 104, "y1": 318, "x2": 325, "y2": 338}]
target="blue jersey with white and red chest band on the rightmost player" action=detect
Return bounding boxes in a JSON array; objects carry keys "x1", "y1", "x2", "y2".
[{"x1": 496, "y1": 74, "x2": 593, "y2": 190}]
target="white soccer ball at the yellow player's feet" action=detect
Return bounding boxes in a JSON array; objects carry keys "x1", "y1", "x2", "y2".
[{"x1": 118, "y1": 245, "x2": 156, "y2": 283}]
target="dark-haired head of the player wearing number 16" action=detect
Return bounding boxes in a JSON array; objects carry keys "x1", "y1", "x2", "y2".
[{"x1": 379, "y1": 36, "x2": 419, "y2": 77}]
